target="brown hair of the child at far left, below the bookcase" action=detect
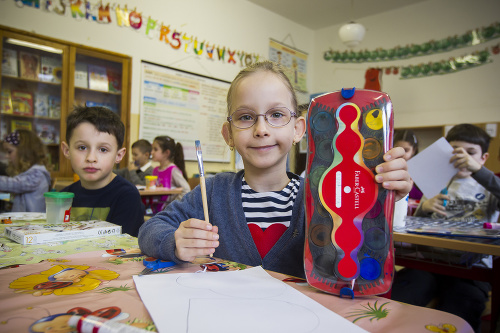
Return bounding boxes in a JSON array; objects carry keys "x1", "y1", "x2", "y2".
[{"x1": 7, "y1": 129, "x2": 50, "y2": 176}]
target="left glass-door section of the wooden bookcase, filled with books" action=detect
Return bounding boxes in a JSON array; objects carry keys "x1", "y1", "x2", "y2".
[{"x1": 0, "y1": 30, "x2": 69, "y2": 176}]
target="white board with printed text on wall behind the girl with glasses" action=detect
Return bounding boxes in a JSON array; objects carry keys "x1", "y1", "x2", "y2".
[{"x1": 139, "y1": 61, "x2": 230, "y2": 163}]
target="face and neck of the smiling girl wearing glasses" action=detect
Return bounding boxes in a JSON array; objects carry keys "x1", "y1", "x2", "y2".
[{"x1": 222, "y1": 71, "x2": 305, "y2": 172}]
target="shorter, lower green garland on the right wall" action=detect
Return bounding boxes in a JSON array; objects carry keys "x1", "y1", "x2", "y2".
[{"x1": 399, "y1": 49, "x2": 492, "y2": 80}]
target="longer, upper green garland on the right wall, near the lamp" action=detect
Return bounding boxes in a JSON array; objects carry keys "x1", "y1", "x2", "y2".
[{"x1": 323, "y1": 22, "x2": 500, "y2": 63}]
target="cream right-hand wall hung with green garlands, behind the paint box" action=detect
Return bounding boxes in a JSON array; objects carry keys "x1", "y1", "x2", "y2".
[{"x1": 311, "y1": 0, "x2": 500, "y2": 128}]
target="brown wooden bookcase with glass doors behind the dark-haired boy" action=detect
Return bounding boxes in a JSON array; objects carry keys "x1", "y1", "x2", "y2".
[{"x1": 0, "y1": 26, "x2": 131, "y2": 178}]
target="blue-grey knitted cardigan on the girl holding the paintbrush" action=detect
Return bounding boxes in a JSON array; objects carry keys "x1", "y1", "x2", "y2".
[{"x1": 139, "y1": 171, "x2": 305, "y2": 278}]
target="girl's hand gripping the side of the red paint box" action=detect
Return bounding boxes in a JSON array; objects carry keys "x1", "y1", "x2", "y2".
[{"x1": 375, "y1": 147, "x2": 413, "y2": 201}]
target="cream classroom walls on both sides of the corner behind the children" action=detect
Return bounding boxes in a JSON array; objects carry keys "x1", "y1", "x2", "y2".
[{"x1": 0, "y1": 0, "x2": 500, "y2": 175}]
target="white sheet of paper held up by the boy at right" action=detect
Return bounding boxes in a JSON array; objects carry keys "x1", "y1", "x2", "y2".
[{"x1": 408, "y1": 138, "x2": 458, "y2": 198}]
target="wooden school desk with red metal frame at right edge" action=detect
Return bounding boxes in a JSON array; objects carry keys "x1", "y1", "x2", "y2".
[{"x1": 393, "y1": 218, "x2": 500, "y2": 332}]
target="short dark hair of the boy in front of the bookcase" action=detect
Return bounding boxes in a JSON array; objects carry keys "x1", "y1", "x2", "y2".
[{"x1": 66, "y1": 106, "x2": 125, "y2": 149}]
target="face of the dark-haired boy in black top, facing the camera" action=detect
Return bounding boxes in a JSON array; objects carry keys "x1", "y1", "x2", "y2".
[{"x1": 61, "y1": 122, "x2": 125, "y2": 190}]
